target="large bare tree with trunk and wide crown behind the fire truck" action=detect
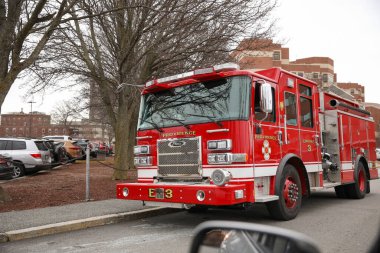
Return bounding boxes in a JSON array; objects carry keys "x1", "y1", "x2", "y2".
[{"x1": 31, "y1": 0, "x2": 276, "y2": 179}]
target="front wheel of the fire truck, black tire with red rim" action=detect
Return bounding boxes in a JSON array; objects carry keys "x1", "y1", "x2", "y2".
[{"x1": 266, "y1": 164, "x2": 302, "y2": 220}]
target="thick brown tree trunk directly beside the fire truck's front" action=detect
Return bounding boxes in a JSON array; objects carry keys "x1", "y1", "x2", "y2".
[{"x1": 112, "y1": 101, "x2": 138, "y2": 179}]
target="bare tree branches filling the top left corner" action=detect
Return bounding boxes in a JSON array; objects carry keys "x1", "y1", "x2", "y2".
[{"x1": 0, "y1": 0, "x2": 79, "y2": 105}]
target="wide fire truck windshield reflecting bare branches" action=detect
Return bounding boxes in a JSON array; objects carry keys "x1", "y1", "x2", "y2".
[{"x1": 138, "y1": 76, "x2": 251, "y2": 130}]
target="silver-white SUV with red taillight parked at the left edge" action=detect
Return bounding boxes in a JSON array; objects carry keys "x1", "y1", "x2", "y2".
[{"x1": 0, "y1": 138, "x2": 52, "y2": 178}]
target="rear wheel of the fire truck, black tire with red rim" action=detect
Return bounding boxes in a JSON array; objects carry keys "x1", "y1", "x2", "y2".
[{"x1": 347, "y1": 162, "x2": 368, "y2": 199}]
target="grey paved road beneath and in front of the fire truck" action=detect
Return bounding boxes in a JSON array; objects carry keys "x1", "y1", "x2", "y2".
[{"x1": 0, "y1": 180, "x2": 380, "y2": 253}]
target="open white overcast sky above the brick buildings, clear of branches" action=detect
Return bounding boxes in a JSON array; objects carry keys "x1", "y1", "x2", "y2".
[{"x1": 1, "y1": 0, "x2": 380, "y2": 113}]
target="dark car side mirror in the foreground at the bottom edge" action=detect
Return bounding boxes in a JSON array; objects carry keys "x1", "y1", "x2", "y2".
[{"x1": 190, "y1": 221, "x2": 321, "y2": 253}]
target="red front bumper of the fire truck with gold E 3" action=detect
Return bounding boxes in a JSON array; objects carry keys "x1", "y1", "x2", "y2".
[{"x1": 116, "y1": 183, "x2": 254, "y2": 206}]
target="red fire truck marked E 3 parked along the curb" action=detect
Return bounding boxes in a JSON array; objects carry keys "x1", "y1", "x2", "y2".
[{"x1": 117, "y1": 63, "x2": 378, "y2": 220}]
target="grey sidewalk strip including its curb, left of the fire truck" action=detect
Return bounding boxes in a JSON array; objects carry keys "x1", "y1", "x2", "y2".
[{"x1": 0, "y1": 199, "x2": 176, "y2": 242}]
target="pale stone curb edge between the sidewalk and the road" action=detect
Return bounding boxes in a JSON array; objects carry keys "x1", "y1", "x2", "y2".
[{"x1": 0, "y1": 207, "x2": 179, "y2": 243}]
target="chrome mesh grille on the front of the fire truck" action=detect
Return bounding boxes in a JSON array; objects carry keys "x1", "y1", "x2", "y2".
[{"x1": 157, "y1": 137, "x2": 201, "y2": 176}]
